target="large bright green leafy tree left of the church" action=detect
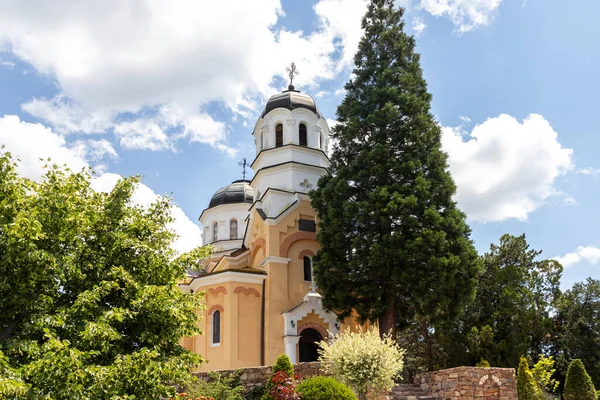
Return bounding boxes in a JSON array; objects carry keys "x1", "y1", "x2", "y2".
[{"x1": 0, "y1": 153, "x2": 209, "y2": 399}]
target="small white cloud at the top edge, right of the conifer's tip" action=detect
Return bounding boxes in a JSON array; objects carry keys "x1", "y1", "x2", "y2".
[{"x1": 420, "y1": 0, "x2": 502, "y2": 33}]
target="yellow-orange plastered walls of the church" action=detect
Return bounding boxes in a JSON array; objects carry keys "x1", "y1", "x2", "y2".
[{"x1": 183, "y1": 200, "x2": 368, "y2": 371}]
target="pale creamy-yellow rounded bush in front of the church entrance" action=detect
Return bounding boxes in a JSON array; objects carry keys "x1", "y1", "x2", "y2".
[{"x1": 319, "y1": 328, "x2": 404, "y2": 396}]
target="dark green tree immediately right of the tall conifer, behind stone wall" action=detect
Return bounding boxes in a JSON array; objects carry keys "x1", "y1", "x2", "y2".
[{"x1": 446, "y1": 235, "x2": 562, "y2": 368}]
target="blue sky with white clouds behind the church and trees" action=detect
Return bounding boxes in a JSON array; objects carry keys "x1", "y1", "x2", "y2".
[{"x1": 0, "y1": 0, "x2": 600, "y2": 288}]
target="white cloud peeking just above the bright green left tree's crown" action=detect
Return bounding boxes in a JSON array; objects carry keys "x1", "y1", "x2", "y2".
[{"x1": 0, "y1": 115, "x2": 200, "y2": 252}]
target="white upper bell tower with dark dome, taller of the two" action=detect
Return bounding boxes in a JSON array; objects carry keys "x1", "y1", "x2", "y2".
[{"x1": 250, "y1": 74, "x2": 329, "y2": 218}]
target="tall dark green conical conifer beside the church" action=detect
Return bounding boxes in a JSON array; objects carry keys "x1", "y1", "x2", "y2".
[{"x1": 311, "y1": 0, "x2": 478, "y2": 333}]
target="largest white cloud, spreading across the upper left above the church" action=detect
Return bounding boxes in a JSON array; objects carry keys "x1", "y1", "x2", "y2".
[{"x1": 0, "y1": 0, "x2": 366, "y2": 154}]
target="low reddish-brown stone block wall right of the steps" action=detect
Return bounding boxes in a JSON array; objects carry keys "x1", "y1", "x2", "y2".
[{"x1": 414, "y1": 367, "x2": 517, "y2": 400}]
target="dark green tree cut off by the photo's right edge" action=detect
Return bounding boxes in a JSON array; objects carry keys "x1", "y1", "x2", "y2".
[{"x1": 553, "y1": 278, "x2": 600, "y2": 387}]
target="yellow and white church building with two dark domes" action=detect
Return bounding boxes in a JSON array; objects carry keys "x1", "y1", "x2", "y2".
[{"x1": 180, "y1": 85, "x2": 354, "y2": 370}]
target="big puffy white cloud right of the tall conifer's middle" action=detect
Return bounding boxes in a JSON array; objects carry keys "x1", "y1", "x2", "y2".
[{"x1": 442, "y1": 114, "x2": 574, "y2": 221}]
